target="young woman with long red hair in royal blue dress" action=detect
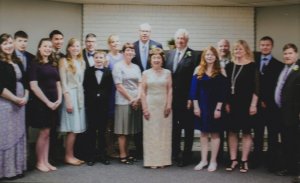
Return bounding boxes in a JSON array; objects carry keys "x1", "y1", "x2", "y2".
[{"x1": 190, "y1": 46, "x2": 227, "y2": 172}]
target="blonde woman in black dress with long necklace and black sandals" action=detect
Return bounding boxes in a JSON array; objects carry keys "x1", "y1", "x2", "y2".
[{"x1": 226, "y1": 40, "x2": 258, "y2": 173}]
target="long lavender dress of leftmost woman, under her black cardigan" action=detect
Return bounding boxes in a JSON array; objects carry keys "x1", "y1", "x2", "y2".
[{"x1": 0, "y1": 64, "x2": 26, "y2": 178}]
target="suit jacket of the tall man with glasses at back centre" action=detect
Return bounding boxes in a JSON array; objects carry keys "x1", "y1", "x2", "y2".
[{"x1": 132, "y1": 40, "x2": 163, "y2": 72}]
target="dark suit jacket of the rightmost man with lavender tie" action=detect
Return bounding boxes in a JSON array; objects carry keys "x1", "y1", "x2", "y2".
[{"x1": 281, "y1": 60, "x2": 300, "y2": 126}]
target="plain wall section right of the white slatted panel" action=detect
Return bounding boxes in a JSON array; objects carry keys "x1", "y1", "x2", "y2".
[{"x1": 256, "y1": 5, "x2": 300, "y2": 60}]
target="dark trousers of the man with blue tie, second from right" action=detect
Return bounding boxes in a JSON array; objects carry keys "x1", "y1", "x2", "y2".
[{"x1": 253, "y1": 106, "x2": 282, "y2": 169}]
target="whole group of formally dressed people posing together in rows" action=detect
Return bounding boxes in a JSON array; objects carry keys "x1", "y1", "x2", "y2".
[{"x1": 0, "y1": 23, "x2": 300, "y2": 182}]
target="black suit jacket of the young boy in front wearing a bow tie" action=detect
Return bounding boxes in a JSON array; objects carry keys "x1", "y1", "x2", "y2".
[{"x1": 83, "y1": 66, "x2": 113, "y2": 122}]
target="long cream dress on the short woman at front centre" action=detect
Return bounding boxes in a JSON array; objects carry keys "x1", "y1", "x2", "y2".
[{"x1": 143, "y1": 69, "x2": 172, "y2": 166}]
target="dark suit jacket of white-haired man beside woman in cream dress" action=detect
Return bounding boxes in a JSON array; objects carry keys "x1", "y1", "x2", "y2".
[{"x1": 165, "y1": 48, "x2": 200, "y2": 107}]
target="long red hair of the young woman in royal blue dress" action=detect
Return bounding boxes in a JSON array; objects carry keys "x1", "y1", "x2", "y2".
[{"x1": 197, "y1": 46, "x2": 221, "y2": 79}]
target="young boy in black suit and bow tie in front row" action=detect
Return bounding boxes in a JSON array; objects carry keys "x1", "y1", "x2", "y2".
[{"x1": 83, "y1": 52, "x2": 113, "y2": 166}]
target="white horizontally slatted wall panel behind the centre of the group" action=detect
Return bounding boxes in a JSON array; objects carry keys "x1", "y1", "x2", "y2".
[{"x1": 83, "y1": 4, "x2": 254, "y2": 50}]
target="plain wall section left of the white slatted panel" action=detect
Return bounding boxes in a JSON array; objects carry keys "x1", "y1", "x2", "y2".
[{"x1": 0, "y1": 0, "x2": 82, "y2": 54}]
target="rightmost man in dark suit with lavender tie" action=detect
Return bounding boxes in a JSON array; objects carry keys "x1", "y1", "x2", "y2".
[{"x1": 275, "y1": 43, "x2": 300, "y2": 179}]
